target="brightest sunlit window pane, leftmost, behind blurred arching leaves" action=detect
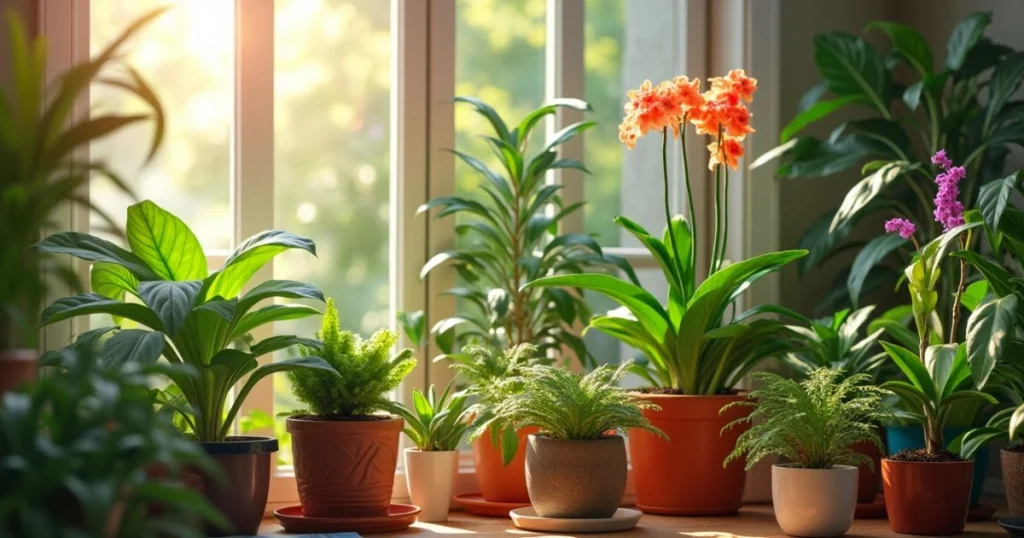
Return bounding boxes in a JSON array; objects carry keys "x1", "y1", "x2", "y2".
[{"x1": 89, "y1": 0, "x2": 234, "y2": 250}]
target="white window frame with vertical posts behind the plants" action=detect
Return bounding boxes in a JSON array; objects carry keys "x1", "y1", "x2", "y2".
[{"x1": 37, "y1": 0, "x2": 779, "y2": 512}]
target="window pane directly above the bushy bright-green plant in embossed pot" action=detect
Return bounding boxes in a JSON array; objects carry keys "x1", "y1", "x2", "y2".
[{"x1": 273, "y1": 0, "x2": 391, "y2": 463}]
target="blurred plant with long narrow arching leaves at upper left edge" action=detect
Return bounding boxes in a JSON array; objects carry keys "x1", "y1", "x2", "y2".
[{"x1": 0, "y1": 9, "x2": 164, "y2": 349}]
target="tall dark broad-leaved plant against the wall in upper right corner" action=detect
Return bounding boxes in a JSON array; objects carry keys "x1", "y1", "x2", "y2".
[{"x1": 753, "y1": 12, "x2": 1024, "y2": 321}]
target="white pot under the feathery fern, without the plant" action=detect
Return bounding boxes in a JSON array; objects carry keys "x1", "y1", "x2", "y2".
[{"x1": 771, "y1": 464, "x2": 857, "y2": 538}]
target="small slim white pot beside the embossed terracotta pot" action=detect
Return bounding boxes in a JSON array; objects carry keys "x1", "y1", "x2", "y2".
[{"x1": 406, "y1": 448, "x2": 459, "y2": 523}]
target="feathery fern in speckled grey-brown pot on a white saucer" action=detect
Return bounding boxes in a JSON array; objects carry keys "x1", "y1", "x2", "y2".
[{"x1": 473, "y1": 362, "x2": 665, "y2": 519}]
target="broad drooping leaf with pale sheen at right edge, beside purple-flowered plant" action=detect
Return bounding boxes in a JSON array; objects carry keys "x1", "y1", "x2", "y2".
[{"x1": 967, "y1": 295, "x2": 1017, "y2": 388}]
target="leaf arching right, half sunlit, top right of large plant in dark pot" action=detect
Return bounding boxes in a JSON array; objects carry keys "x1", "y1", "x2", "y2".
[{"x1": 204, "y1": 230, "x2": 316, "y2": 299}]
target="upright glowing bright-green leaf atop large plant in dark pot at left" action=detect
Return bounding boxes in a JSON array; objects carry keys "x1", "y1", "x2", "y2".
[{"x1": 126, "y1": 200, "x2": 207, "y2": 281}]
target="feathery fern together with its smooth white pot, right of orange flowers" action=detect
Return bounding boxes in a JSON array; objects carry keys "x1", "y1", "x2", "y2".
[{"x1": 727, "y1": 367, "x2": 887, "y2": 537}]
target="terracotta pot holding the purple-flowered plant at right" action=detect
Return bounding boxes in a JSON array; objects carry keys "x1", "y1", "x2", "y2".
[{"x1": 882, "y1": 458, "x2": 974, "y2": 536}]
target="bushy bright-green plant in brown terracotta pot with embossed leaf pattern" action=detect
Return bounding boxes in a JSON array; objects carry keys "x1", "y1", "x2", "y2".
[{"x1": 286, "y1": 299, "x2": 416, "y2": 518}]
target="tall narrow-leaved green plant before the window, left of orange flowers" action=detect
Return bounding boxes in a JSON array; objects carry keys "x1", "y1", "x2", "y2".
[{"x1": 419, "y1": 97, "x2": 636, "y2": 364}]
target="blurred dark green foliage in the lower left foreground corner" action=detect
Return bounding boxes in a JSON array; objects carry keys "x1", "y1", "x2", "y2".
[{"x1": 0, "y1": 338, "x2": 228, "y2": 538}]
